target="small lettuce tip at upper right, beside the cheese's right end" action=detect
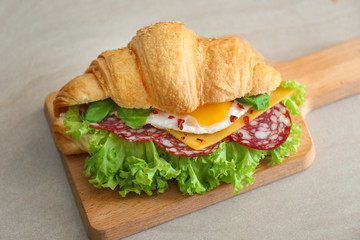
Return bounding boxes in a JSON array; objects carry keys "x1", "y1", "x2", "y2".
[{"x1": 280, "y1": 80, "x2": 306, "y2": 115}]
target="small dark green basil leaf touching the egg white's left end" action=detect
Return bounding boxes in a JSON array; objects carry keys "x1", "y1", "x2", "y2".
[{"x1": 118, "y1": 107, "x2": 151, "y2": 129}]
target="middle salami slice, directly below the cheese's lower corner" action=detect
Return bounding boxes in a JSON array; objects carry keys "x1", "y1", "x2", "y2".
[{"x1": 155, "y1": 134, "x2": 221, "y2": 157}]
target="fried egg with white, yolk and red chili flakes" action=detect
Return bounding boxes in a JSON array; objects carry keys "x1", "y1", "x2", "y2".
[{"x1": 146, "y1": 101, "x2": 251, "y2": 134}]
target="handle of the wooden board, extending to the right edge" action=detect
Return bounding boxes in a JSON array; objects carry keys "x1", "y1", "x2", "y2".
[{"x1": 273, "y1": 37, "x2": 360, "y2": 113}]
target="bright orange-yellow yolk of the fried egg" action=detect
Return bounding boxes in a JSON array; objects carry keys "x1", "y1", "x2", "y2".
[{"x1": 189, "y1": 102, "x2": 232, "y2": 126}]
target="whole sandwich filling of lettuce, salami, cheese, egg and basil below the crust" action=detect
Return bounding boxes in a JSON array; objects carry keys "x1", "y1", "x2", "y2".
[{"x1": 64, "y1": 81, "x2": 305, "y2": 196}]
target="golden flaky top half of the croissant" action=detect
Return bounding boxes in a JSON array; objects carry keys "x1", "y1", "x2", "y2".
[{"x1": 54, "y1": 22, "x2": 281, "y2": 116}]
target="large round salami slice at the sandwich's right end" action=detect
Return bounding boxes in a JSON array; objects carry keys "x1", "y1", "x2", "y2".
[{"x1": 229, "y1": 103, "x2": 292, "y2": 150}]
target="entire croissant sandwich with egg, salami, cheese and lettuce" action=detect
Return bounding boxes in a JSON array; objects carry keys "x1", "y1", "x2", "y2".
[{"x1": 53, "y1": 22, "x2": 305, "y2": 196}]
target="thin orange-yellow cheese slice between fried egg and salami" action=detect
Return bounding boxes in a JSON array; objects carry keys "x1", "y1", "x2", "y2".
[{"x1": 169, "y1": 87, "x2": 296, "y2": 150}]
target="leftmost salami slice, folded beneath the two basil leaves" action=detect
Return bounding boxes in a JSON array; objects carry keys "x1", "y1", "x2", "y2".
[{"x1": 90, "y1": 116, "x2": 167, "y2": 142}]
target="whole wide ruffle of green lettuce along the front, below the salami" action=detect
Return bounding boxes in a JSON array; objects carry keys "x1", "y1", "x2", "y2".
[{"x1": 84, "y1": 130, "x2": 266, "y2": 196}]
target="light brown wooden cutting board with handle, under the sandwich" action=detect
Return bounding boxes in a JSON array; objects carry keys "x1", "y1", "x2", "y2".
[{"x1": 45, "y1": 37, "x2": 360, "y2": 239}]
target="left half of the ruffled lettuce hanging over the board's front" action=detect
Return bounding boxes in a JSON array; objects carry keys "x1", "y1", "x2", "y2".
[{"x1": 84, "y1": 130, "x2": 180, "y2": 196}]
